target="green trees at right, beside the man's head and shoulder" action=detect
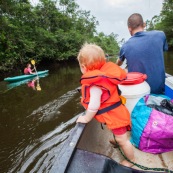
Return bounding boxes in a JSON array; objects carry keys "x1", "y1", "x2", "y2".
[{"x1": 147, "y1": 0, "x2": 173, "y2": 50}]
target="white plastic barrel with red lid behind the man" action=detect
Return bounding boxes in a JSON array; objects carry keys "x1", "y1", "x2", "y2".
[{"x1": 118, "y1": 72, "x2": 150, "y2": 114}]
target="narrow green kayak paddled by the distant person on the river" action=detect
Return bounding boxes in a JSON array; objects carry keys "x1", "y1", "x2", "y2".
[{"x1": 4, "y1": 70, "x2": 49, "y2": 82}]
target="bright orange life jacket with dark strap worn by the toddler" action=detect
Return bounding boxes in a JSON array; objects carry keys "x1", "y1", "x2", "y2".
[{"x1": 80, "y1": 62, "x2": 131, "y2": 129}]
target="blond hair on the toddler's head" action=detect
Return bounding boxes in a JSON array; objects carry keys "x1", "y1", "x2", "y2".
[{"x1": 77, "y1": 43, "x2": 106, "y2": 70}]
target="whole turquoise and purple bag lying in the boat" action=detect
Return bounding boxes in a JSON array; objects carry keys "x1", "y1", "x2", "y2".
[{"x1": 131, "y1": 95, "x2": 173, "y2": 154}]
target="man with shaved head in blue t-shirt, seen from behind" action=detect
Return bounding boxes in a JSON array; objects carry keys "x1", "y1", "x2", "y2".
[{"x1": 117, "y1": 13, "x2": 168, "y2": 94}]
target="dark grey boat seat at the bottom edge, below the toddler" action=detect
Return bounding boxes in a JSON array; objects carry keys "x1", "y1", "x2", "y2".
[{"x1": 65, "y1": 149, "x2": 160, "y2": 173}]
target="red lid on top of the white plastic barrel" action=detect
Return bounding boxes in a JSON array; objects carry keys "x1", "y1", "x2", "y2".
[{"x1": 120, "y1": 72, "x2": 147, "y2": 85}]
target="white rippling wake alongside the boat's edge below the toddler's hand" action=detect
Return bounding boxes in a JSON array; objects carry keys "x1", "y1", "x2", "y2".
[{"x1": 10, "y1": 111, "x2": 77, "y2": 173}]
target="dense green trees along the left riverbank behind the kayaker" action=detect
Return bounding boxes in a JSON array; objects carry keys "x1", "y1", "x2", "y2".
[{"x1": 0, "y1": 0, "x2": 119, "y2": 72}]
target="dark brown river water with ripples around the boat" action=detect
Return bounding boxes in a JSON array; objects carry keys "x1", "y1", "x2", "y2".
[{"x1": 0, "y1": 52, "x2": 173, "y2": 173}]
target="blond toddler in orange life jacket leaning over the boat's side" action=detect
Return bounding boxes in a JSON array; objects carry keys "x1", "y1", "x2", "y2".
[{"x1": 76, "y1": 43, "x2": 134, "y2": 167}]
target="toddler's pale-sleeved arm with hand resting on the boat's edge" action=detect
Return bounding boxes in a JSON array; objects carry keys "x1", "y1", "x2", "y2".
[{"x1": 76, "y1": 86, "x2": 102, "y2": 123}]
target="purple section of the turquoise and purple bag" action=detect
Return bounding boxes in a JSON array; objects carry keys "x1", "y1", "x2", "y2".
[{"x1": 139, "y1": 109, "x2": 173, "y2": 154}]
